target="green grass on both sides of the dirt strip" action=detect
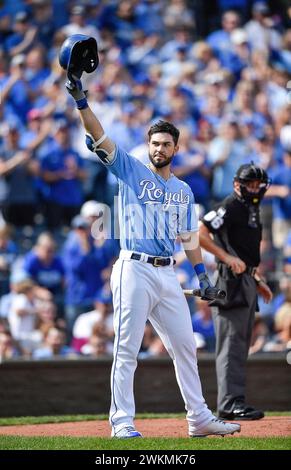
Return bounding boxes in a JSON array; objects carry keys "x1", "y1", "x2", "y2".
[{"x1": 0, "y1": 412, "x2": 291, "y2": 451}]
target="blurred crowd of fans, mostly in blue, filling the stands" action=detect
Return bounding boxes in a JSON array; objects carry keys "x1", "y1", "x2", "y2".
[{"x1": 0, "y1": 0, "x2": 291, "y2": 360}]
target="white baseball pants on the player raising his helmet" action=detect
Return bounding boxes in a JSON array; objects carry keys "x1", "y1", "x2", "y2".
[{"x1": 110, "y1": 250, "x2": 213, "y2": 431}]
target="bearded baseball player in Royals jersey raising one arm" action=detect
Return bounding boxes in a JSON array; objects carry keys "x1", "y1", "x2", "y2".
[{"x1": 60, "y1": 35, "x2": 240, "y2": 438}]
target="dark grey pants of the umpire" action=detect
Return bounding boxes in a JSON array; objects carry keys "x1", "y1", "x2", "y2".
[{"x1": 212, "y1": 274, "x2": 257, "y2": 412}]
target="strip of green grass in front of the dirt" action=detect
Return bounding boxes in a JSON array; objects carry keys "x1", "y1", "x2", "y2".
[{"x1": 0, "y1": 436, "x2": 291, "y2": 451}]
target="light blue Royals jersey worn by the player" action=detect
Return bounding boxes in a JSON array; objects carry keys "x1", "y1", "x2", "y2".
[{"x1": 106, "y1": 147, "x2": 198, "y2": 256}]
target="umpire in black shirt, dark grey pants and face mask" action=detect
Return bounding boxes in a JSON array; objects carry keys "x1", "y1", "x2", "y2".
[{"x1": 200, "y1": 163, "x2": 272, "y2": 420}]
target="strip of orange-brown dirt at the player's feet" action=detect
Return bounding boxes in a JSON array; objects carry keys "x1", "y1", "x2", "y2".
[{"x1": 0, "y1": 416, "x2": 291, "y2": 439}]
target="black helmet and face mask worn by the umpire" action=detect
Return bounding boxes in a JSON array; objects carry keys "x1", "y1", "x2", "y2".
[{"x1": 234, "y1": 162, "x2": 271, "y2": 205}]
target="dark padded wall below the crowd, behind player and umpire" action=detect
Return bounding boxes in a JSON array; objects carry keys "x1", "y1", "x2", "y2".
[{"x1": 0, "y1": 354, "x2": 291, "y2": 417}]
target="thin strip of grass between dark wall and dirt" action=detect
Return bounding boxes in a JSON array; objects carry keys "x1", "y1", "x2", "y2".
[{"x1": 0, "y1": 411, "x2": 291, "y2": 426}]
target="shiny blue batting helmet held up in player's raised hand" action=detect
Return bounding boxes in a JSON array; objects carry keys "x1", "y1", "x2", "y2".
[{"x1": 59, "y1": 34, "x2": 99, "y2": 78}]
